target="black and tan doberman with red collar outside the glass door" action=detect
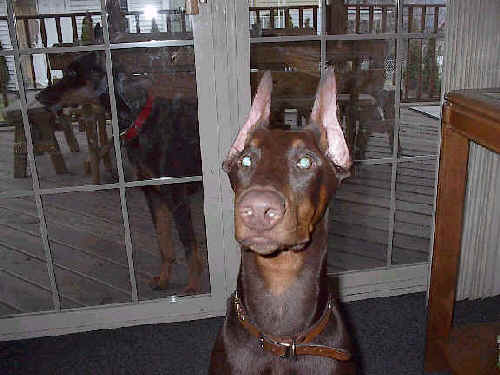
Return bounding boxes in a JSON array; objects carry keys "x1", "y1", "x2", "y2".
[{"x1": 37, "y1": 52, "x2": 203, "y2": 293}]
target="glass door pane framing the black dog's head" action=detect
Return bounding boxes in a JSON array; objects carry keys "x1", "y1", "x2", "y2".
[{"x1": 21, "y1": 52, "x2": 117, "y2": 188}]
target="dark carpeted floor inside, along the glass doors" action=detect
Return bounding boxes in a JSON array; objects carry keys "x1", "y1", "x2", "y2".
[{"x1": 0, "y1": 293, "x2": 500, "y2": 375}]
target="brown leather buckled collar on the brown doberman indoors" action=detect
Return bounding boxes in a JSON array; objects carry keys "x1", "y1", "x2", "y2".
[{"x1": 232, "y1": 290, "x2": 352, "y2": 361}]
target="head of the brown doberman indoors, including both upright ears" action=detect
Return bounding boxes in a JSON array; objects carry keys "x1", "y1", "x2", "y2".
[{"x1": 223, "y1": 71, "x2": 352, "y2": 255}]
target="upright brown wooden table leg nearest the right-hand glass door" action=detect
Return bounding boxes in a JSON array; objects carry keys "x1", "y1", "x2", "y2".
[{"x1": 425, "y1": 105, "x2": 469, "y2": 372}]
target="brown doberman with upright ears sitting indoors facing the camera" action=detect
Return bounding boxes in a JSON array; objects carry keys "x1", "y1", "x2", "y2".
[{"x1": 210, "y1": 71, "x2": 355, "y2": 375}]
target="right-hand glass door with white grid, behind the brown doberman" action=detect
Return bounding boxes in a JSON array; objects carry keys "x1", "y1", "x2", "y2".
[{"x1": 248, "y1": 0, "x2": 446, "y2": 300}]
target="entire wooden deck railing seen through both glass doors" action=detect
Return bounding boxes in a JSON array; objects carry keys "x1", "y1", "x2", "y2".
[{"x1": 5, "y1": 3, "x2": 445, "y2": 101}]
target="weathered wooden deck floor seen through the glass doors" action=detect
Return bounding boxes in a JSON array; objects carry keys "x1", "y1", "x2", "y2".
[{"x1": 0, "y1": 110, "x2": 439, "y2": 316}]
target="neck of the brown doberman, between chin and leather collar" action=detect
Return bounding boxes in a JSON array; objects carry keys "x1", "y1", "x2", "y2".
[{"x1": 238, "y1": 215, "x2": 329, "y2": 336}]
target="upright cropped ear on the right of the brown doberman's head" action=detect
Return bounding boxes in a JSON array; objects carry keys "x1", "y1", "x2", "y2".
[{"x1": 309, "y1": 69, "x2": 352, "y2": 178}]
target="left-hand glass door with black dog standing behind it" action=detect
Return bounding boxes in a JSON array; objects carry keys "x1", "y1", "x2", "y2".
[{"x1": 0, "y1": 0, "x2": 226, "y2": 339}]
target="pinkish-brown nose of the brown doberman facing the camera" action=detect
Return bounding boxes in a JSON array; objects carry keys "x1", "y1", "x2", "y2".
[{"x1": 237, "y1": 190, "x2": 285, "y2": 230}]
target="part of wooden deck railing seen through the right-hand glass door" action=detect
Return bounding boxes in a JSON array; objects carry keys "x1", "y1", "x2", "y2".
[{"x1": 249, "y1": 3, "x2": 446, "y2": 102}]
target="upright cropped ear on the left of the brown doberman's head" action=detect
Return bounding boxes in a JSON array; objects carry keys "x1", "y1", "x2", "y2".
[{"x1": 222, "y1": 70, "x2": 273, "y2": 172}]
